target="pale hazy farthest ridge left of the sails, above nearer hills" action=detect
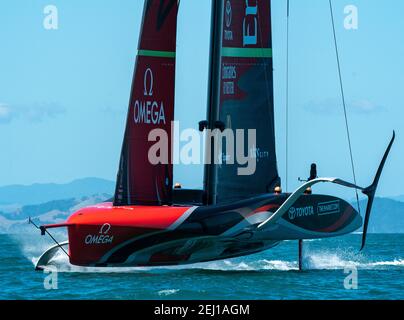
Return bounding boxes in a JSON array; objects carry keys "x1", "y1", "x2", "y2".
[{"x1": 0, "y1": 178, "x2": 115, "y2": 205}]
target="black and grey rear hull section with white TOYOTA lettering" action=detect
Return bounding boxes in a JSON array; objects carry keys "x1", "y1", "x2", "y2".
[{"x1": 97, "y1": 194, "x2": 362, "y2": 267}]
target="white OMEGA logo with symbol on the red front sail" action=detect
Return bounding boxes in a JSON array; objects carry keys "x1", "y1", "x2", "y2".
[{"x1": 133, "y1": 68, "x2": 166, "y2": 125}]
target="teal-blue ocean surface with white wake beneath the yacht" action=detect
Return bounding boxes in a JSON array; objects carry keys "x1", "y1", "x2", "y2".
[{"x1": 0, "y1": 233, "x2": 404, "y2": 300}]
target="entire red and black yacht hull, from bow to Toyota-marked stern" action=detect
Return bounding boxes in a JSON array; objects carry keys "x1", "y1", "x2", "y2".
[{"x1": 38, "y1": 194, "x2": 362, "y2": 267}]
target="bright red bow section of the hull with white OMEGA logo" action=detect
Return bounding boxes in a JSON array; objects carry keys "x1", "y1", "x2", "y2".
[{"x1": 67, "y1": 203, "x2": 189, "y2": 266}]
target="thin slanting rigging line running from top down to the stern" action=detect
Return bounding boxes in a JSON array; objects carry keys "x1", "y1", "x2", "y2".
[{"x1": 329, "y1": 0, "x2": 361, "y2": 213}]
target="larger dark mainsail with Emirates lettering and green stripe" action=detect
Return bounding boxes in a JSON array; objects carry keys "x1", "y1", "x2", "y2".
[{"x1": 216, "y1": 0, "x2": 280, "y2": 203}]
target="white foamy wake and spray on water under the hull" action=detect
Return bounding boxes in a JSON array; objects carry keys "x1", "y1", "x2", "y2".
[{"x1": 16, "y1": 233, "x2": 404, "y2": 273}]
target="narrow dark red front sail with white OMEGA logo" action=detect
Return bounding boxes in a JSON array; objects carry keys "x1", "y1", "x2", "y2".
[{"x1": 114, "y1": 0, "x2": 178, "y2": 206}]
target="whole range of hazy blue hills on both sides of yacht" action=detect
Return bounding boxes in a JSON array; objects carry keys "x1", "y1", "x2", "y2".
[{"x1": 0, "y1": 178, "x2": 404, "y2": 233}]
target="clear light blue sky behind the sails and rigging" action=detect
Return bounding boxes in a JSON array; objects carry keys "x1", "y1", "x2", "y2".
[{"x1": 0, "y1": 0, "x2": 404, "y2": 197}]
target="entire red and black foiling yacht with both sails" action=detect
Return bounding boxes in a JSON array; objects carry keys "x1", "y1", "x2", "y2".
[{"x1": 33, "y1": 0, "x2": 394, "y2": 269}]
